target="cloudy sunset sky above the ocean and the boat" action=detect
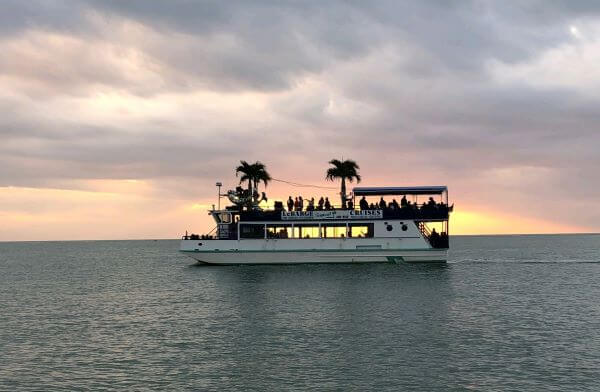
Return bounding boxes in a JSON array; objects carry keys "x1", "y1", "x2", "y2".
[{"x1": 0, "y1": 0, "x2": 600, "y2": 241}]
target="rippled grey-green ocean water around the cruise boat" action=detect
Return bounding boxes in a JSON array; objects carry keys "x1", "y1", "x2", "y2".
[{"x1": 0, "y1": 235, "x2": 600, "y2": 391}]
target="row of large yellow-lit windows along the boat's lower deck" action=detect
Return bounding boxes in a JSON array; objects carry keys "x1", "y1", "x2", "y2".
[{"x1": 240, "y1": 223, "x2": 374, "y2": 239}]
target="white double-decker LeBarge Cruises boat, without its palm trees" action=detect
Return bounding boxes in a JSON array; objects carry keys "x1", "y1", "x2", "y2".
[{"x1": 180, "y1": 183, "x2": 453, "y2": 264}]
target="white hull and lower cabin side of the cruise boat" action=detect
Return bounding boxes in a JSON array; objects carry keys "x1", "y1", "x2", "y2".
[{"x1": 180, "y1": 220, "x2": 447, "y2": 264}]
